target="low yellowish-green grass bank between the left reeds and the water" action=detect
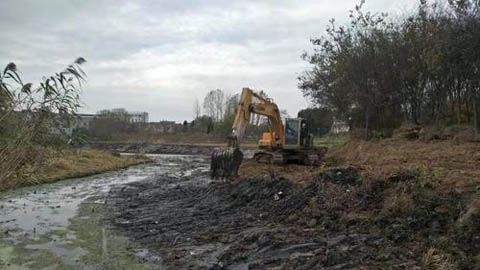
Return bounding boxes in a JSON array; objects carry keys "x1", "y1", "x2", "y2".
[{"x1": 0, "y1": 148, "x2": 150, "y2": 192}]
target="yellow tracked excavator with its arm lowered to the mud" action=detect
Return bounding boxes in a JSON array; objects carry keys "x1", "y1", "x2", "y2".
[{"x1": 210, "y1": 88, "x2": 326, "y2": 178}]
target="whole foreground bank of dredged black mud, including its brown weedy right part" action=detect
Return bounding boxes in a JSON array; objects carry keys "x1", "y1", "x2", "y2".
[{"x1": 107, "y1": 161, "x2": 479, "y2": 269}]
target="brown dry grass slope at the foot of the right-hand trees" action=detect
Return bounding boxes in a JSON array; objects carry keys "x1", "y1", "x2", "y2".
[{"x1": 327, "y1": 140, "x2": 480, "y2": 193}]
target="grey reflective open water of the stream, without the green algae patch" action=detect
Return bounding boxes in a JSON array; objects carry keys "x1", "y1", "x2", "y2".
[{"x1": 0, "y1": 155, "x2": 208, "y2": 269}]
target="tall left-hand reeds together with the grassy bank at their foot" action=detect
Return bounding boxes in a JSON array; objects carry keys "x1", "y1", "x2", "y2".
[{"x1": 0, "y1": 57, "x2": 148, "y2": 191}]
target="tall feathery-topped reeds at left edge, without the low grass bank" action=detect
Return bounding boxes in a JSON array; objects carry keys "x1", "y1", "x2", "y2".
[{"x1": 0, "y1": 57, "x2": 86, "y2": 190}]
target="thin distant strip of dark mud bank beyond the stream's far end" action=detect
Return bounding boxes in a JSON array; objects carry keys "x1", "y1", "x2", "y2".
[{"x1": 87, "y1": 143, "x2": 215, "y2": 155}]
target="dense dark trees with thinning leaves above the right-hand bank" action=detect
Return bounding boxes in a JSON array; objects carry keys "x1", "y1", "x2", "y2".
[{"x1": 298, "y1": 0, "x2": 480, "y2": 136}]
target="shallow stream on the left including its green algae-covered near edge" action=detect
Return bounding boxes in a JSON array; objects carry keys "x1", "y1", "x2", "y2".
[{"x1": 0, "y1": 155, "x2": 204, "y2": 269}]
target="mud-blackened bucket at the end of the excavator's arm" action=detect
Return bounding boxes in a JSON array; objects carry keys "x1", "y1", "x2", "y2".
[{"x1": 210, "y1": 147, "x2": 243, "y2": 179}]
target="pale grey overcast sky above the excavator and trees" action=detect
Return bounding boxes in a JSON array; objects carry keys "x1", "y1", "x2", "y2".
[{"x1": 0, "y1": 0, "x2": 418, "y2": 121}]
